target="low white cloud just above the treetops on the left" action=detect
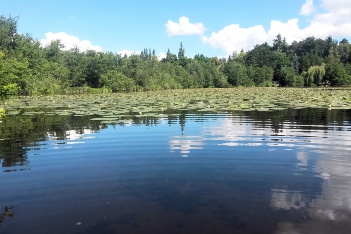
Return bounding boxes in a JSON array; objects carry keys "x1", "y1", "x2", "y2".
[{"x1": 40, "y1": 32, "x2": 102, "y2": 51}]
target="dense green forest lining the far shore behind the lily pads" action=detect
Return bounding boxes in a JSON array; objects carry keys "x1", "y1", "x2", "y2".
[{"x1": 0, "y1": 16, "x2": 351, "y2": 95}]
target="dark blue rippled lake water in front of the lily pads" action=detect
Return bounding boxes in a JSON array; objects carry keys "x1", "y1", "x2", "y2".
[{"x1": 0, "y1": 109, "x2": 351, "y2": 233}]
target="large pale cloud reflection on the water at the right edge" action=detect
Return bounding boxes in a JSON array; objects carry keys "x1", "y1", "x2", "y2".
[{"x1": 271, "y1": 126, "x2": 351, "y2": 234}]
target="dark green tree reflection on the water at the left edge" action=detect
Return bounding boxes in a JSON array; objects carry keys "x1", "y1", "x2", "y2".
[{"x1": 0, "y1": 114, "x2": 107, "y2": 172}]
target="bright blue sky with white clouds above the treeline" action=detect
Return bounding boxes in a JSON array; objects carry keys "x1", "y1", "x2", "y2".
[{"x1": 0, "y1": 0, "x2": 351, "y2": 57}]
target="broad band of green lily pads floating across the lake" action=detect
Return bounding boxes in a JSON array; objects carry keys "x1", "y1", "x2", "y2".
[{"x1": 0, "y1": 87, "x2": 351, "y2": 120}]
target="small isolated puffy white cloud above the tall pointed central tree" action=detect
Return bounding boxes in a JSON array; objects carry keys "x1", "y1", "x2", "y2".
[{"x1": 166, "y1": 16, "x2": 206, "y2": 37}]
